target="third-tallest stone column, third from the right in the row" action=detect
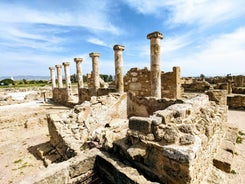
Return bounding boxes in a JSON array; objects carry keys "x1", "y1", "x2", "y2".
[{"x1": 89, "y1": 52, "x2": 100, "y2": 92}]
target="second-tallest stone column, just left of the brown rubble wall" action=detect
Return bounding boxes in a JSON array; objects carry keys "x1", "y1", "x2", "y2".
[{"x1": 113, "y1": 45, "x2": 125, "y2": 93}]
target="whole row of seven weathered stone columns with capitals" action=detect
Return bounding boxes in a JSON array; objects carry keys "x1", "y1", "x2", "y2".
[{"x1": 49, "y1": 32, "x2": 163, "y2": 98}]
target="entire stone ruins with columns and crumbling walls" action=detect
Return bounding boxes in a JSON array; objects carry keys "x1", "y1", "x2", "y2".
[{"x1": 1, "y1": 32, "x2": 245, "y2": 184}]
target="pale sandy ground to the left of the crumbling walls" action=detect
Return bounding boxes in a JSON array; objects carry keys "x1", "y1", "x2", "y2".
[{"x1": 0, "y1": 96, "x2": 71, "y2": 183}]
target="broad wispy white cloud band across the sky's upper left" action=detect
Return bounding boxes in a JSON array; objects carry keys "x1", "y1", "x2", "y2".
[{"x1": 0, "y1": 1, "x2": 120, "y2": 35}]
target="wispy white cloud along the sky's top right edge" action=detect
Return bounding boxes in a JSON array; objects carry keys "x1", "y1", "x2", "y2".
[{"x1": 123, "y1": 0, "x2": 245, "y2": 27}]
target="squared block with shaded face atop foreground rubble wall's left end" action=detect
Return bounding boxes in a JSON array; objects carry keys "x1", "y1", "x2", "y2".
[{"x1": 129, "y1": 116, "x2": 151, "y2": 134}]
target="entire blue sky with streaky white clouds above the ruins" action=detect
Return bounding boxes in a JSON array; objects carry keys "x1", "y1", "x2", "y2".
[{"x1": 0, "y1": 0, "x2": 245, "y2": 76}]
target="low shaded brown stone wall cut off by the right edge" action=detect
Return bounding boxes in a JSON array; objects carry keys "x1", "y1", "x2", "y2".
[{"x1": 227, "y1": 95, "x2": 245, "y2": 110}]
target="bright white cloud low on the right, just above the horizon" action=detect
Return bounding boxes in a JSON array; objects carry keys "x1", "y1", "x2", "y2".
[{"x1": 162, "y1": 27, "x2": 245, "y2": 75}]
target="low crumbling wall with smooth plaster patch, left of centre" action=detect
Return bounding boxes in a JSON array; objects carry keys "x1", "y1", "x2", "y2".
[{"x1": 47, "y1": 93, "x2": 128, "y2": 160}]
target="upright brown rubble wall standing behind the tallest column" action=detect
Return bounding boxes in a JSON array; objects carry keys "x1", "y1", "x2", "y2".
[{"x1": 124, "y1": 67, "x2": 181, "y2": 98}]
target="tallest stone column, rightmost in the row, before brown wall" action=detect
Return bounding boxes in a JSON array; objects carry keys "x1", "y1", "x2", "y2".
[{"x1": 147, "y1": 32, "x2": 163, "y2": 98}]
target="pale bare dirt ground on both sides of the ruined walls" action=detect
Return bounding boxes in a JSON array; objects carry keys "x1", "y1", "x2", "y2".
[{"x1": 0, "y1": 91, "x2": 245, "y2": 184}]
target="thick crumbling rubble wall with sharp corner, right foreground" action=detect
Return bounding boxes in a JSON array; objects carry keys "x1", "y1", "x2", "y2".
[{"x1": 114, "y1": 94, "x2": 227, "y2": 184}]
